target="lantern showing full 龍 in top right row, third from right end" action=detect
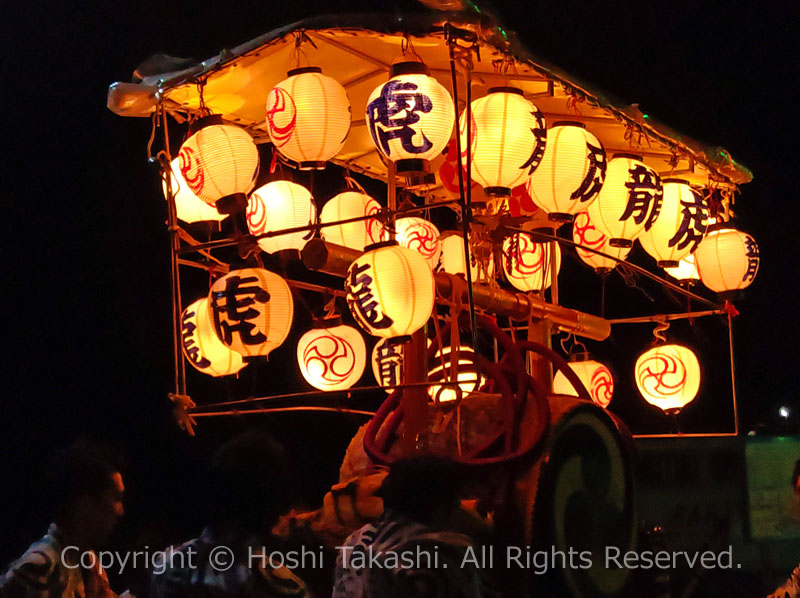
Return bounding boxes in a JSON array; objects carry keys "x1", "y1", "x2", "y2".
[{"x1": 588, "y1": 154, "x2": 663, "y2": 247}]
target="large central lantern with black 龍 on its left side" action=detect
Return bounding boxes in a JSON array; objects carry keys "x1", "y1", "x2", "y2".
[{"x1": 345, "y1": 244, "x2": 435, "y2": 338}]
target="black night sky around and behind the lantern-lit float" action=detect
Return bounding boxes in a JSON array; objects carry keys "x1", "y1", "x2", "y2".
[{"x1": 0, "y1": 0, "x2": 800, "y2": 562}]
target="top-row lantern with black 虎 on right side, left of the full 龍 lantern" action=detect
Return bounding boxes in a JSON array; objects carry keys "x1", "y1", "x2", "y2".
[{"x1": 527, "y1": 122, "x2": 606, "y2": 222}]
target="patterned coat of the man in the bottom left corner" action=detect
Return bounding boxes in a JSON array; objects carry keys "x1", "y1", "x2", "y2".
[{"x1": 0, "y1": 523, "x2": 117, "y2": 598}]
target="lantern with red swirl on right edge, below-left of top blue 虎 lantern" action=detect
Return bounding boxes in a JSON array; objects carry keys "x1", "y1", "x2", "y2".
[{"x1": 319, "y1": 191, "x2": 383, "y2": 251}]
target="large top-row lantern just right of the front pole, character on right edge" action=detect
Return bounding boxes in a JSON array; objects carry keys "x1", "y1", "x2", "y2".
[{"x1": 459, "y1": 87, "x2": 547, "y2": 197}]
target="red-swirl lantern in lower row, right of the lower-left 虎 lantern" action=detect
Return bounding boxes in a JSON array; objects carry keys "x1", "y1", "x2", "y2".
[{"x1": 297, "y1": 319, "x2": 367, "y2": 390}]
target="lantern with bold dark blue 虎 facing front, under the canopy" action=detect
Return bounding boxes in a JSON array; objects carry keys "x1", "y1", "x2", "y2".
[{"x1": 367, "y1": 62, "x2": 455, "y2": 173}]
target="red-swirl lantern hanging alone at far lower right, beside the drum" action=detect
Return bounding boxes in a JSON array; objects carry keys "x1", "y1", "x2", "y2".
[{"x1": 635, "y1": 345, "x2": 700, "y2": 413}]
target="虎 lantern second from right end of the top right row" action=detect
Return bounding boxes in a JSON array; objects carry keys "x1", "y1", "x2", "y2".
[{"x1": 639, "y1": 179, "x2": 708, "y2": 268}]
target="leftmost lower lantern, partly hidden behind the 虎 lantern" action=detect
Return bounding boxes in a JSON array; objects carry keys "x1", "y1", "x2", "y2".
[{"x1": 181, "y1": 297, "x2": 245, "y2": 377}]
